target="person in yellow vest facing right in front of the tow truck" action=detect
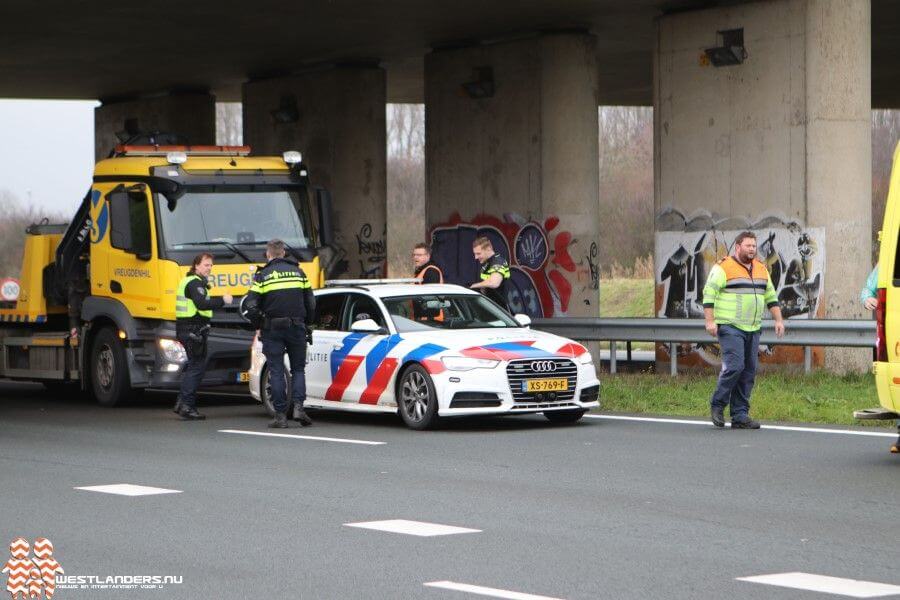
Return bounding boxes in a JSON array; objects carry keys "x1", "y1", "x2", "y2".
[{"x1": 175, "y1": 253, "x2": 233, "y2": 421}]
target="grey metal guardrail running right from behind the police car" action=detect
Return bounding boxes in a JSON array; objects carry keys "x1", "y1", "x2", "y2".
[{"x1": 531, "y1": 317, "x2": 875, "y2": 375}]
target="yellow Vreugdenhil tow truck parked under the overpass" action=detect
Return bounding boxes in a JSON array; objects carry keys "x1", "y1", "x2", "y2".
[{"x1": 0, "y1": 145, "x2": 333, "y2": 406}]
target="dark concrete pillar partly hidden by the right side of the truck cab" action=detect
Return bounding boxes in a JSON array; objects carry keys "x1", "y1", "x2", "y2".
[{"x1": 243, "y1": 66, "x2": 387, "y2": 278}]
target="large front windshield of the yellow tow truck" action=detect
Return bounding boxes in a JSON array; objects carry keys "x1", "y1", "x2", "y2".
[{"x1": 153, "y1": 186, "x2": 312, "y2": 252}]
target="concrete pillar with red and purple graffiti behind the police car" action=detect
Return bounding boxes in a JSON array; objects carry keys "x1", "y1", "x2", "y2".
[{"x1": 425, "y1": 32, "x2": 600, "y2": 317}]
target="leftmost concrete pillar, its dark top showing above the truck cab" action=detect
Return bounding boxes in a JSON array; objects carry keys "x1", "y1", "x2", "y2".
[{"x1": 94, "y1": 92, "x2": 216, "y2": 160}]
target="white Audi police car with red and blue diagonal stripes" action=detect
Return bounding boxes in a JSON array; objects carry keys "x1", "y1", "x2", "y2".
[{"x1": 250, "y1": 280, "x2": 600, "y2": 429}]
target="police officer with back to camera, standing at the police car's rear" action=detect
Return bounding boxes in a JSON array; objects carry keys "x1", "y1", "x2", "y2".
[{"x1": 244, "y1": 239, "x2": 316, "y2": 428}]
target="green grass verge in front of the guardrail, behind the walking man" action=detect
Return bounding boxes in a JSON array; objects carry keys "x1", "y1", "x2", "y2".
[{"x1": 600, "y1": 372, "x2": 895, "y2": 429}]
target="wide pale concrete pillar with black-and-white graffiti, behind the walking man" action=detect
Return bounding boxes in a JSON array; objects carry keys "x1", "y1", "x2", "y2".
[{"x1": 654, "y1": 0, "x2": 872, "y2": 371}]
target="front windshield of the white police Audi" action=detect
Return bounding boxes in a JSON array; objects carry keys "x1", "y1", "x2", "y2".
[{"x1": 382, "y1": 294, "x2": 520, "y2": 333}]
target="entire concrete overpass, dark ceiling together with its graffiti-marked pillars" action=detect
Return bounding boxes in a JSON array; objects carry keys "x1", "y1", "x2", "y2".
[{"x1": 0, "y1": 0, "x2": 900, "y2": 368}]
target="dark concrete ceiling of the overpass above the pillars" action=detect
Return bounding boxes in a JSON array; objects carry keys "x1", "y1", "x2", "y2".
[{"x1": 0, "y1": 0, "x2": 900, "y2": 107}]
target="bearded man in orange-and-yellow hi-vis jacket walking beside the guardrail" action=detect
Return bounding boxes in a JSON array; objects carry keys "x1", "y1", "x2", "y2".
[{"x1": 703, "y1": 231, "x2": 784, "y2": 429}]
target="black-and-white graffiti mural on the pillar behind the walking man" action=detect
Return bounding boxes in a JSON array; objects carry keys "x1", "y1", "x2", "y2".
[{"x1": 655, "y1": 209, "x2": 825, "y2": 362}]
